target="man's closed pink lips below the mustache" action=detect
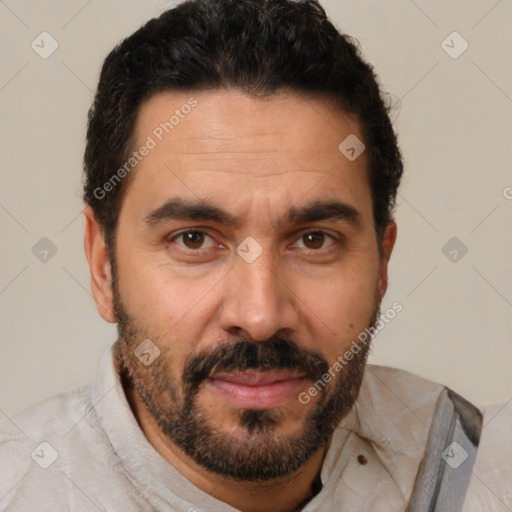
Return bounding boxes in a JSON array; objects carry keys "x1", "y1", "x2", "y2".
[{"x1": 207, "y1": 370, "x2": 304, "y2": 410}]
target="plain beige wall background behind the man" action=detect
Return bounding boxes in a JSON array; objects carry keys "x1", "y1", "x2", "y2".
[{"x1": 0, "y1": 0, "x2": 512, "y2": 416}]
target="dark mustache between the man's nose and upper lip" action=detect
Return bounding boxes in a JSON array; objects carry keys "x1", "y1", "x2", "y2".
[{"x1": 183, "y1": 337, "x2": 329, "y2": 389}]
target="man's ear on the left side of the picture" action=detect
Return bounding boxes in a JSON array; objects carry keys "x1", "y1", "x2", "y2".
[{"x1": 84, "y1": 206, "x2": 116, "y2": 323}]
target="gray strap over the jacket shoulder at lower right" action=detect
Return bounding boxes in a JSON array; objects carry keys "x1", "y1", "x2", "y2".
[{"x1": 406, "y1": 389, "x2": 482, "y2": 512}]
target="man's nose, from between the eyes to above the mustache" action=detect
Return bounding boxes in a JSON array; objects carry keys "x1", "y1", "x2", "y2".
[{"x1": 220, "y1": 247, "x2": 299, "y2": 341}]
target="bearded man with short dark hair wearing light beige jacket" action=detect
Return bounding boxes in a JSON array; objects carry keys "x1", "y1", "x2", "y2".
[{"x1": 0, "y1": 0, "x2": 510, "y2": 512}]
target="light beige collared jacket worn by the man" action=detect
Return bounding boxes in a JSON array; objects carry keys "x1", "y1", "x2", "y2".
[{"x1": 0, "y1": 349, "x2": 512, "y2": 512}]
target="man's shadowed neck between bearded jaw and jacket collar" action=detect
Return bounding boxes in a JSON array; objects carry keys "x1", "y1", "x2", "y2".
[{"x1": 123, "y1": 381, "x2": 328, "y2": 512}]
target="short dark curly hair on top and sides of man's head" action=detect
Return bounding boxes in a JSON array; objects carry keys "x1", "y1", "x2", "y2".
[{"x1": 84, "y1": 0, "x2": 403, "y2": 249}]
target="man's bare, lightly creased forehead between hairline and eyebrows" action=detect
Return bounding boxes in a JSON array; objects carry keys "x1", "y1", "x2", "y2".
[{"x1": 127, "y1": 90, "x2": 370, "y2": 224}]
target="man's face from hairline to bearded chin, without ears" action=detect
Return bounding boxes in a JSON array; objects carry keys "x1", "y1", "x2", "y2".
[{"x1": 108, "y1": 90, "x2": 394, "y2": 480}]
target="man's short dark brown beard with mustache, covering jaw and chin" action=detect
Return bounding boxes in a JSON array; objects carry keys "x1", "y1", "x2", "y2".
[{"x1": 113, "y1": 268, "x2": 379, "y2": 482}]
